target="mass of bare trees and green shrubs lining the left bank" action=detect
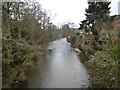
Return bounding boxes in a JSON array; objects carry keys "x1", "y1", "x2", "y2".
[{"x1": 0, "y1": 2, "x2": 56, "y2": 88}]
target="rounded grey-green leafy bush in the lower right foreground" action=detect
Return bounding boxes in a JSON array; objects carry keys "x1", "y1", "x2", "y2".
[{"x1": 86, "y1": 51, "x2": 118, "y2": 88}]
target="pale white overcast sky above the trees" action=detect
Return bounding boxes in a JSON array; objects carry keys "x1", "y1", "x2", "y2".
[{"x1": 37, "y1": 0, "x2": 120, "y2": 26}]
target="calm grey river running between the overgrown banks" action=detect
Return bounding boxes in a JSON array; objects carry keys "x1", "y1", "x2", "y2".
[{"x1": 19, "y1": 38, "x2": 89, "y2": 88}]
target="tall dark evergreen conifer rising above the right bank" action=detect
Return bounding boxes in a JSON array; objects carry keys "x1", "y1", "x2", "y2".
[{"x1": 80, "y1": 0, "x2": 111, "y2": 49}]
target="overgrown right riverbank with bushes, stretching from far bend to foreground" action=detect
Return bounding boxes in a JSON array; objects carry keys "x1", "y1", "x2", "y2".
[{"x1": 67, "y1": 36, "x2": 120, "y2": 88}]
